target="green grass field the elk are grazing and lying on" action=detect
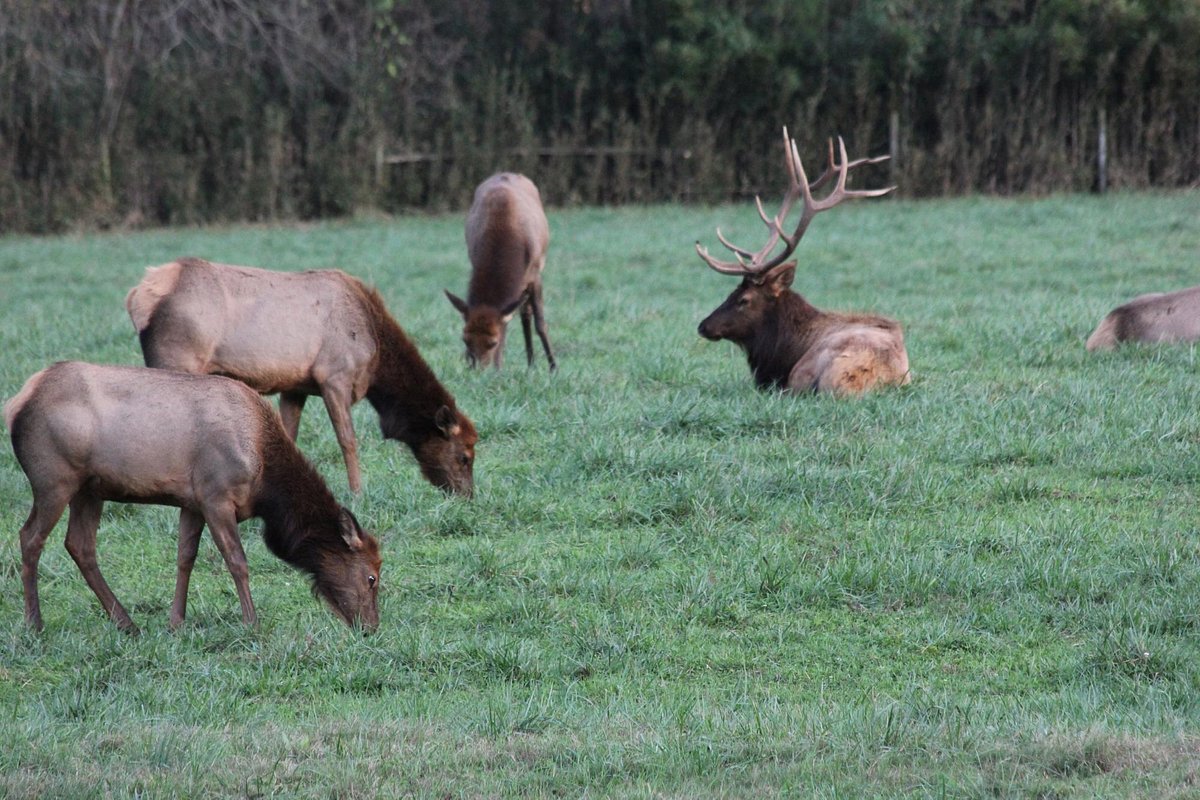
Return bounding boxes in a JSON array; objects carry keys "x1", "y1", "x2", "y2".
[{"x1": 0, "y1": 192, "x2": 1200, "y2": 798}]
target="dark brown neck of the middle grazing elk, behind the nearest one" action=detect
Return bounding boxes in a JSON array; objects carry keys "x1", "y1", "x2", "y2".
[{"x1": 357, "y1": 290, "x2": 455, "y2": 447}]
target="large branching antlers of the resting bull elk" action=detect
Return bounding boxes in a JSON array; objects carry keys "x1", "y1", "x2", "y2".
[{"x1": 696, "y1": 127, "x2": 895, "y2": 276}]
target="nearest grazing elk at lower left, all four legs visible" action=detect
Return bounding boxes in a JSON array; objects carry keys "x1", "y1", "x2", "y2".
[{"x1": 4, "y1": 361, "x2": 380, "y2": 633}]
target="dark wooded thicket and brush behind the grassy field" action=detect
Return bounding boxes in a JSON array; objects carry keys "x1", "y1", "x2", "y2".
[{"x1": 0, "y1": 0, "x2": 1200, "y2": 231}]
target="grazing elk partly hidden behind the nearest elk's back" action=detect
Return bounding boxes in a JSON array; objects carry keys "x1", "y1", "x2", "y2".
[{"x1": 125, "y1": 258, "x2": 479, "y2": 497}]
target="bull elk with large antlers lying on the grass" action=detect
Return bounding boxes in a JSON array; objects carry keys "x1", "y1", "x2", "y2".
[{"x1": 696, "y1": 128, "x2": 910, "y2": 395}]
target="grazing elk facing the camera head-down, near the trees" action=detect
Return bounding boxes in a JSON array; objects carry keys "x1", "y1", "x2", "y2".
[{"x1": 445, "y1": 173, "x2": 557, "y2": 369}]
